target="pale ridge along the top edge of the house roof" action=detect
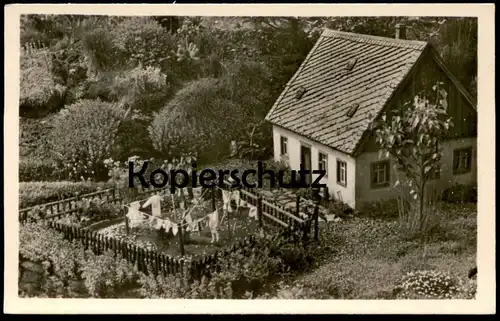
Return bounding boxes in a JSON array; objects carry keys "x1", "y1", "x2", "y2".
[{"x1": 321, "y1": 28, "x2": 428, "y2": 49}]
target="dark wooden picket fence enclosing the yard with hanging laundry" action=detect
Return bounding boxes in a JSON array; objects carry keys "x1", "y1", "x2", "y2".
[{"x1": 19, "y1": 182, "x2": 318, "y2": 280}]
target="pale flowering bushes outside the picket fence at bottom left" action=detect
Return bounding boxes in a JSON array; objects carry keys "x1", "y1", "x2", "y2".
[{"x1": 19, "y1": 222, "x2": 140, "y2": 298}]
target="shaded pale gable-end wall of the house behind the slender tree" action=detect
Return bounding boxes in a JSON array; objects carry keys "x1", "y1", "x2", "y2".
[{"x1": 355, "y1": 138, "x2": 477, "y2": 206}]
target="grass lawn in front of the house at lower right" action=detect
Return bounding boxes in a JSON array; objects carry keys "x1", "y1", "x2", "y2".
[{"x1": 293, "y1": 204, "x2": 477, "y2": 299}]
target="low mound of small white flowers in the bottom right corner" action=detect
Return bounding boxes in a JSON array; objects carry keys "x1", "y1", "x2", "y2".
[{"x1": 395, "y1": 270, "x2": 468, "y2": 299}]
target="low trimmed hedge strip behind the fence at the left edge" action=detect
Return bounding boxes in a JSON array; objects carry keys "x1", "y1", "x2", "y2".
[{"x1": 19, "y1": 181, "x2": 113, "y2": 209}]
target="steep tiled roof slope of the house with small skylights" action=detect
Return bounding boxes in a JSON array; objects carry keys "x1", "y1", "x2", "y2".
[{"x1": 266, "y1": 29, "x2": 427, "y2": 154}]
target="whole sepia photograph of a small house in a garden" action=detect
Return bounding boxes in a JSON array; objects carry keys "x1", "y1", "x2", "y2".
[{"x1": 4, "y1": 5, "x2": 495, "y2": 313}]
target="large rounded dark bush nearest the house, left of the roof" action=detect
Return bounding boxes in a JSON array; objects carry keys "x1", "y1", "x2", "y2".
[{"x1": 149, "y1": 78, "x2": 238, "y2": 158}]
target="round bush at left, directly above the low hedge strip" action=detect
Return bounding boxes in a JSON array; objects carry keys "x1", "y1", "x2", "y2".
[{"x1": 50, "y1": 100, "x2": 124, "y2": 180}]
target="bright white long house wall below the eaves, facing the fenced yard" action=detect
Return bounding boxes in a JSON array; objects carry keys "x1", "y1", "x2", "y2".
[{"x1": 273, "y1": 126, "x2": 356, "y2": 207}]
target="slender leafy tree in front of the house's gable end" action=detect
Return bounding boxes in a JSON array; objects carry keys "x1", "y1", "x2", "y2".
[{"x1": 375, "y1": 83, "x2": 452, "y2": 233}]
